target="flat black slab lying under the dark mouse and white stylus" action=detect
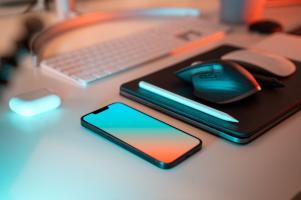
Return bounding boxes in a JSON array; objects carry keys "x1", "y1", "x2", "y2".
[{"x1": 120, "y1": 45, "x2": 301, "y2": 143}]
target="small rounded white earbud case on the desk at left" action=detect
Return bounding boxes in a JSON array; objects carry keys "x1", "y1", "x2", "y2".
[{"x1": 9, "y1": 88, "x2": 61, "y2": 117}]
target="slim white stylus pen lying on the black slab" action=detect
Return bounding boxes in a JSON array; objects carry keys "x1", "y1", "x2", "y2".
[{"x1": 139, "y1": 81, "x2": 239, "y2": 123}]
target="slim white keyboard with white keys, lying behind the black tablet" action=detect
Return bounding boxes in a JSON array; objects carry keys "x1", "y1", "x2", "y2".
[{"x1": 41, "y1": 18, "x2": 225, "y2": 86}]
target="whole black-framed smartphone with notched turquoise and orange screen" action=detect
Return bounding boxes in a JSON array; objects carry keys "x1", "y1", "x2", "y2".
[{"x1": 81, "y1": 102, "x2": 202, "y2": 169}]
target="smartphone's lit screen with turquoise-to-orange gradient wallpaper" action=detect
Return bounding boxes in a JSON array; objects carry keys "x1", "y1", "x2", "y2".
[{"x1": 84, "y1": 103, "x2": 200, "y2": 163}]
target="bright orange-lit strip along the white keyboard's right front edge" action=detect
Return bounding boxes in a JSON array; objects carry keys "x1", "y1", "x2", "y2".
[{"x1": 170, "y1": 32, "x2": 225, "y2": 56}]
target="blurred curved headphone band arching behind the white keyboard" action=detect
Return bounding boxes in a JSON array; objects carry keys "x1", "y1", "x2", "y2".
[{"x1": 31, "y1": 8, "x2": 200, "y2": 65}]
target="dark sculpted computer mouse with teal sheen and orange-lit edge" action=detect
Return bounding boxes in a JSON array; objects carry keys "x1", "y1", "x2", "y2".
[{"x1": 176, "y1": 60, "x2": 261, "y2": 104}]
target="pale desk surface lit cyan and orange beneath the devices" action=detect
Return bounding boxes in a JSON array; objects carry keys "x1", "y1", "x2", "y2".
[{"x1": 0, "y1": 0, "x2": 301, "y2": 200}]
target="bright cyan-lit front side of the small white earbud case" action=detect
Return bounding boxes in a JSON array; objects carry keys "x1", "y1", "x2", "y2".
[{"x1": 9, "y1": 94, "x2": 61, "y2": 117}]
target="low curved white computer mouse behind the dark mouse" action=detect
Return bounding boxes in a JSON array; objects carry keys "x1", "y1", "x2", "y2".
[{"x1": 222, "y1": 49, "x2": 296, "y2": 77}]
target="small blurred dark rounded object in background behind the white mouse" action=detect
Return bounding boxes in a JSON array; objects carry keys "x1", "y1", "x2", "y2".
[{"x1": 249, "y1": 20, "x2": 283, "y2": 34}]
